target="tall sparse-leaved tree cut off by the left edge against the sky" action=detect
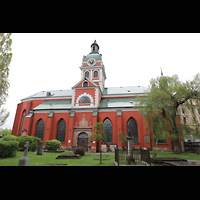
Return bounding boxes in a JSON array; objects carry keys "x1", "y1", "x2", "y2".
[{"x1": 0, "y1": 33, "x2": 12, "y2": 126}]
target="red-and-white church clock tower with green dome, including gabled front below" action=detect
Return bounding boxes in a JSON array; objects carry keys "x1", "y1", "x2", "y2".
[{"x1": 72, "y1": 40, "x2": 106, "y2": 108}]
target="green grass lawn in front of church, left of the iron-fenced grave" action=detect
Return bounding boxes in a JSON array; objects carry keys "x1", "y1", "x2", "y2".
[{"x1": 0, "y1": 151, "x2": 115, "y2": 166}]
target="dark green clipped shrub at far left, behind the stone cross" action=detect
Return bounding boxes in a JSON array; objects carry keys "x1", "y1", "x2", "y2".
[{"x1": 0, "y1": 140, "x2": 19, "y2": 158}]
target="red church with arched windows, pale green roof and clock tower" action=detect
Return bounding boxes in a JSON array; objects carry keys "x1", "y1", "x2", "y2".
[{"x1": 12, "y1": 40, "x2": 171, "y2": 152}]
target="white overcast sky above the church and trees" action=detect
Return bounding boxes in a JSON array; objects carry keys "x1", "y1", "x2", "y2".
[{"x1": 2, "y1": 33, "x2": 200, "y2": 129}]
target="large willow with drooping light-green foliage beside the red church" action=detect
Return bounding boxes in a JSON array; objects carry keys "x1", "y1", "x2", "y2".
[{"x1": 137, "y1": 74, "x2": 200, "y2": 153}]
